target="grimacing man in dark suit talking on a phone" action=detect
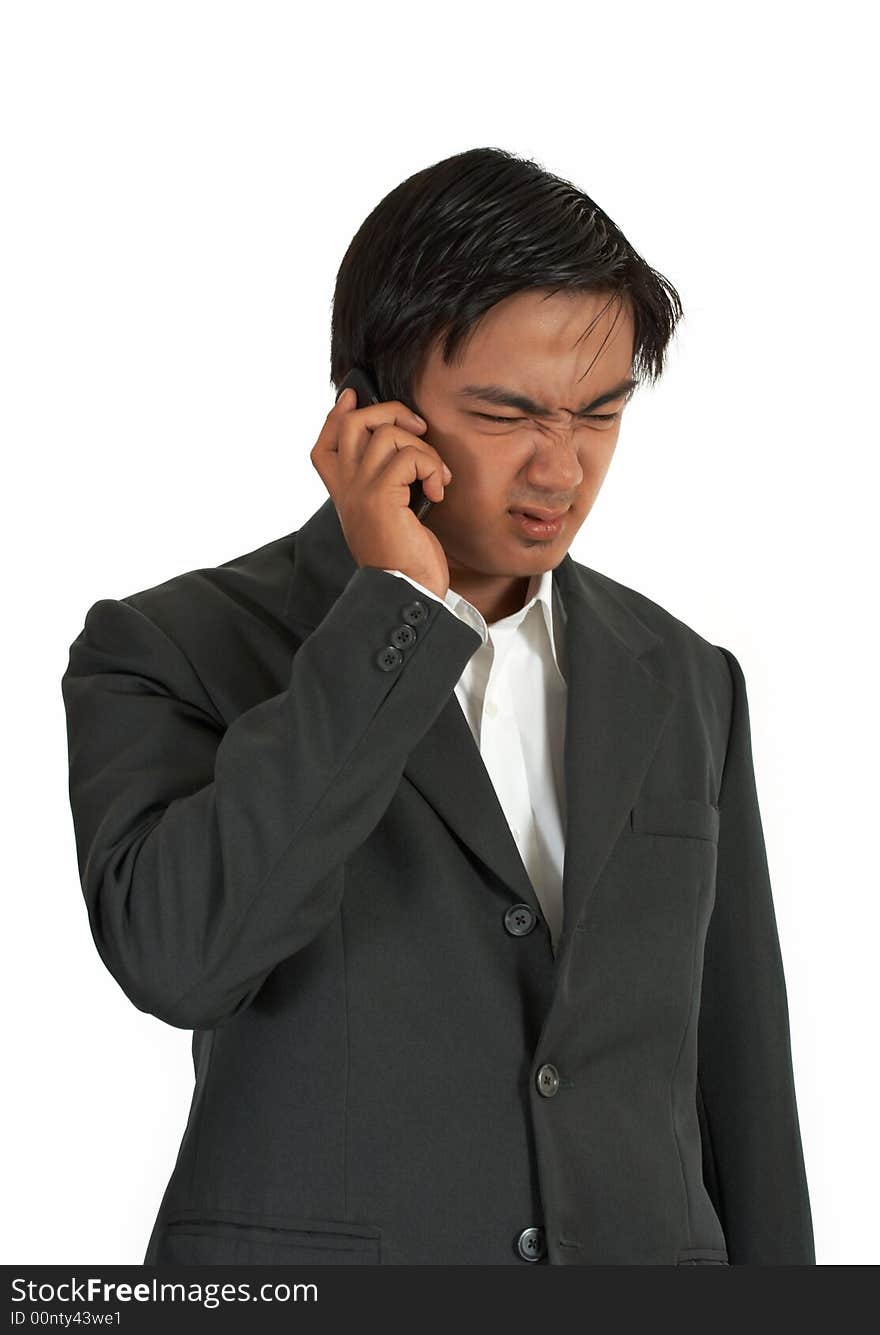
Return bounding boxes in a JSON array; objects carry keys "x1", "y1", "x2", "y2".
[{"x1": 63, "y1": 150, "x2": 815, "y2": 1266}]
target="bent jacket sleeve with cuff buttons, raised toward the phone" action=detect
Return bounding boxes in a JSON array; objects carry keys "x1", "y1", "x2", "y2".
[{"x1": 61, "y1": 566, "x2": 481, "y2": 1029}]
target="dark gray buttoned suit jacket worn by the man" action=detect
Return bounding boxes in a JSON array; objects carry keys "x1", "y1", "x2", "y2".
[{"x1": 63, "y1": 499, "x2": 815, "y2": 1266}]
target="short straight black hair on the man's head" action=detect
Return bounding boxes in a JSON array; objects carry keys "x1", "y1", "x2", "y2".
[{"x1": 330, "y1": 148, "x2": 682, "y2": 403}]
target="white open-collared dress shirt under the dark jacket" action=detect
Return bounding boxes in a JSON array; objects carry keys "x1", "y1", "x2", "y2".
[{"x1": 387, "y1": 570, "x2": 568, "y2": 953}]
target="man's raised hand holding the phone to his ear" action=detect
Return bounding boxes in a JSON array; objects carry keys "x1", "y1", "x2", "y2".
[{"x1": 311, "y1": 371, "x2": 451, "y2": 598}]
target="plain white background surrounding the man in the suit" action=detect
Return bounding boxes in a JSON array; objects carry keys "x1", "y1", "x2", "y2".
[{"x1": 0, "y1": 0, "x2": 880, "y2": 1264}]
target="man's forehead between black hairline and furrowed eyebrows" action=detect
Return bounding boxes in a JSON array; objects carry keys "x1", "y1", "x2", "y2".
[{"x1": 426, "y1": 288, "x2": 633, "y2": 395}]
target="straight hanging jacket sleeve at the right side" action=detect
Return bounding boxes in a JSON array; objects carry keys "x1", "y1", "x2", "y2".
[{"x1": 698, "y1": 646, "x2": 816, "y2": 1266}]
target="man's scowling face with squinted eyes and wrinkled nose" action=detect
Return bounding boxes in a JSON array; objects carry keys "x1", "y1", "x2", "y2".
[{"x1": 411, "y1": 288, "x2": 633, "y2": 591}]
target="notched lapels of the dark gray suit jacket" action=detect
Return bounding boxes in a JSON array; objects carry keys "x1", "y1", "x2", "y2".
[{"x1": 286, "y1": 498, "x2": 676, "y2": 961}]
